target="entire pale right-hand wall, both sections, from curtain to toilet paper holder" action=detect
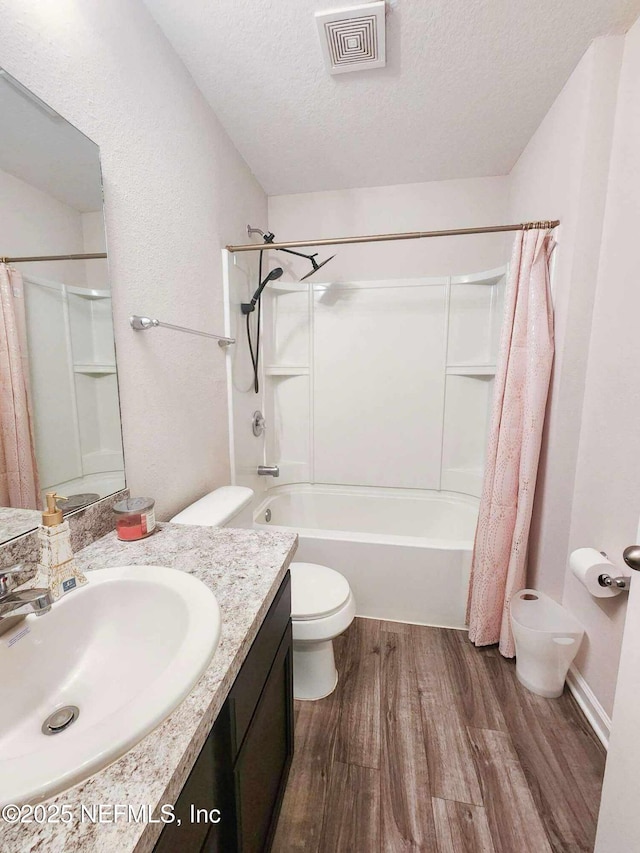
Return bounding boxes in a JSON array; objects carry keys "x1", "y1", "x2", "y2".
[{"x1": 511, "y1": 33, "x2": 640, "y2": 714}]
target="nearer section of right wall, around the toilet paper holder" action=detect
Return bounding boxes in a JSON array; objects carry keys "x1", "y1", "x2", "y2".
[{"x1": 563, "y1": 22, "x2": 640, "y2": 713}]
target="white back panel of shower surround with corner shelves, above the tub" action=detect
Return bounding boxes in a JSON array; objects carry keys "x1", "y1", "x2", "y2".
[{"x1": 252, "y1": 267, "x2": 506, "y2": 497}]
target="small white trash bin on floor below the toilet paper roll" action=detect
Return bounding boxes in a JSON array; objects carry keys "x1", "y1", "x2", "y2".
[{"x1": 510, "y1": 589, "x2": 584, "y2": 699}]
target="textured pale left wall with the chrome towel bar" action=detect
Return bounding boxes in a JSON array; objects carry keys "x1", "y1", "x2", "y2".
[{"x1": 0, "y1": 0, "x2": 267, "y2": 519}]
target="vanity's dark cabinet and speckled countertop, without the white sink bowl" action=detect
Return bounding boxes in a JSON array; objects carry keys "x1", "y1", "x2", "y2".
[{"x1": 0, "y1": 524, "x2": 297, "y2": 853}]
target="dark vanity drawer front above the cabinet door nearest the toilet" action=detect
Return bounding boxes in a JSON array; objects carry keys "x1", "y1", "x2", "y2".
[{"x1": 229, "y1": 572, "x2": 291, "y2": 759}]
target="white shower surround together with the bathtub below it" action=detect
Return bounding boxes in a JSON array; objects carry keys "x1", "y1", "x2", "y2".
[{"x1": 228, "y1": 260, "x2": 506, "y2": 628}]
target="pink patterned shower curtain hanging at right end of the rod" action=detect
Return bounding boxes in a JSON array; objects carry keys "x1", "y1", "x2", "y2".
[{"x1": 467, "y1": 230, "x2": 553, "y2": 657}]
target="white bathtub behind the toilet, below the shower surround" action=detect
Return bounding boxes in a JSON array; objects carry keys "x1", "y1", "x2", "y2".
[{"x1": 254, "y1": 485, "x2": 478, "y2": 628}]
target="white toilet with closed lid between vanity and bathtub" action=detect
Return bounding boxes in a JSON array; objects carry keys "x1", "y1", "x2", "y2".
[{"x1": 171, "y1": 486, "x2": 356, "y2": 699}]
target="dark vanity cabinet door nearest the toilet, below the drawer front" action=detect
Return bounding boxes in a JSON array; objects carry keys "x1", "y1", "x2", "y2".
[{"x1": 234, "y1": 625, "x2": 293, "y2": 853}]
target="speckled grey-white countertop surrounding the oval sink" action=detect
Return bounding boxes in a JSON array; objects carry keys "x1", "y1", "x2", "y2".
[{"x1": 0, "y1": 524, "x2": 297, "y2": 853}]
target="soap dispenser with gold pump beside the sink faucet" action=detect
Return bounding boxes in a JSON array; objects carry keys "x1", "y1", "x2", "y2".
[{"x1": 35, "y1": 492, "x2": 87, "y2": 601}]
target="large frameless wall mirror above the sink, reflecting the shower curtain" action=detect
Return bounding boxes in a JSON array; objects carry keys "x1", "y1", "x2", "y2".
[{"x1": 0, "y1": 69, "x2": 125, "y2": 542}]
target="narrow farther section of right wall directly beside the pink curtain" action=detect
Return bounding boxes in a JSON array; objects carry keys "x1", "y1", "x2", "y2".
[{"x1": 510, "y1": 37, "x2": 623, "y2": 600}]
